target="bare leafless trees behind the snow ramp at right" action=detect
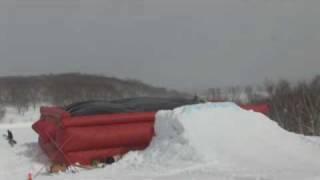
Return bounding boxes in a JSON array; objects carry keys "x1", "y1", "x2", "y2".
[{"x1": 206, "y1": 75, "x2": 320, "y2": 135}]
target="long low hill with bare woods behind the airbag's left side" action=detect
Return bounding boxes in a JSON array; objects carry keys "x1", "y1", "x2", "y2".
[{"x1": 0, "y1": 73, "x2": 181, "y2": 113}]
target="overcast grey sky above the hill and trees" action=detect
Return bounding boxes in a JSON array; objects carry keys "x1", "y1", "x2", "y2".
[{"x1": 0, "y1": 0, "x2": 320, "y2": 90}]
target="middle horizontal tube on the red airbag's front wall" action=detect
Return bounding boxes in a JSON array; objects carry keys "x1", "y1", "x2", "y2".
[{"x1": 57, "y1": 121, "x2": 153, "y2": 152}]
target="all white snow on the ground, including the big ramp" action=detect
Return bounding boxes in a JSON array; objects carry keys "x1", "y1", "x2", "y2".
[{"x1": 0, "y1": 103, "x2": 320, "y2": 180}]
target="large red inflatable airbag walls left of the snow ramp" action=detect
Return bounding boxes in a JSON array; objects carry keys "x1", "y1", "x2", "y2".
[{"x1": 33, "y1": 107, "x2": 155, "y2": 165}]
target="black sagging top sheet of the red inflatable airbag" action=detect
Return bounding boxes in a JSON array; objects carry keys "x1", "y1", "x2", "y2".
[{"x1": 64, "y1": 97, "x2": 199, "y2": 116}]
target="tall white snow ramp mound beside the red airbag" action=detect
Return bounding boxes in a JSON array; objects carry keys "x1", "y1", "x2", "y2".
[{"x1": 122, "y1": 103, "x2": 320, "y2": 171}]
